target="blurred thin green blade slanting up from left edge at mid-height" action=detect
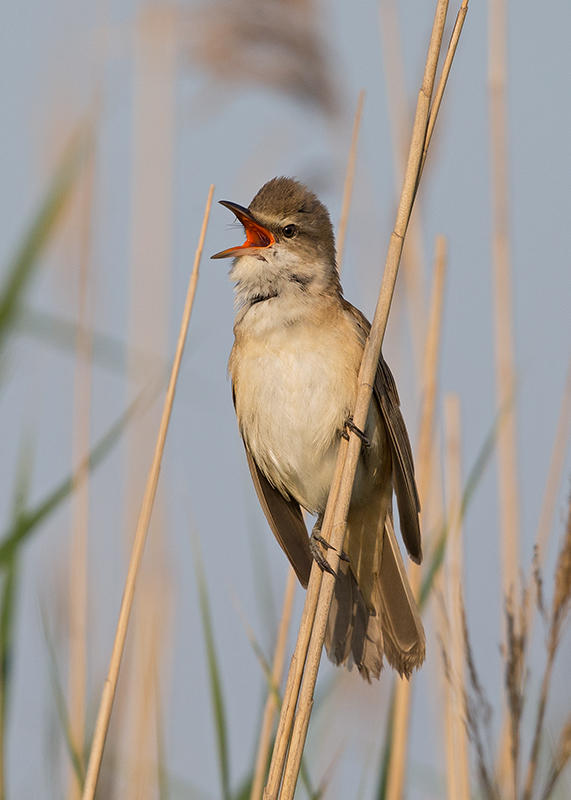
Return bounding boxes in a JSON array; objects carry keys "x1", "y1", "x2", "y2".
[{"x1": 0, "y1": 396, "x2": 145, "y2": 569}]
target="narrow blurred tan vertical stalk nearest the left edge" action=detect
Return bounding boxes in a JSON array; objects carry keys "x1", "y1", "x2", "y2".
[{"x1": 68, "y1": 151, "x2": 95, "y2": 800}]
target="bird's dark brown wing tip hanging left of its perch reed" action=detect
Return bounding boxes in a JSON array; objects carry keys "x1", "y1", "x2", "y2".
[{"x1": 244, "y1": 443, "x2": 312, "y2": 588}]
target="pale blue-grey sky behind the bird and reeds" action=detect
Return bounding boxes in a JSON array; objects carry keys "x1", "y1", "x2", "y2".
[{"x1": 0, "y1": 0, "x2": 571, "y2": 798}]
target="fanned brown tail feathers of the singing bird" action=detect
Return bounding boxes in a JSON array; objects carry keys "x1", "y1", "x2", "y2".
[{"x1": 325, "y1": 509, "x2": 425, "y2": 681}]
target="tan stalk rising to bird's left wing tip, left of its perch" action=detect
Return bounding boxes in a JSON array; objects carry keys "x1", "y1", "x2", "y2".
[{"x1": 250, "y1": 567, "x2": 297, "y2": 800}]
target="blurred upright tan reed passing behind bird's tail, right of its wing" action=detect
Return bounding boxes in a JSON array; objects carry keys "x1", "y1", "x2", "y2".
[{"x1": 387, "y1": 236, "x2": 446, "y2": 798}]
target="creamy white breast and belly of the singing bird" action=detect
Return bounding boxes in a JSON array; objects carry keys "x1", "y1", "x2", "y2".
[{"x1": 230, "y1": 300, "x2": 361, "y2": 511}]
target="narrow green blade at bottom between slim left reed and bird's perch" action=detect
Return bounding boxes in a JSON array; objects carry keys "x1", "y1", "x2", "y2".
[{"x1": 192, "y1": 537, "x2": 232, "y2": 800}]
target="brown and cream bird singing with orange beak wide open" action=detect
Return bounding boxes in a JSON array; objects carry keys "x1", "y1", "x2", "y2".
[{"x1": 212, "y1": 177, "x2": 426, "y2": 682}]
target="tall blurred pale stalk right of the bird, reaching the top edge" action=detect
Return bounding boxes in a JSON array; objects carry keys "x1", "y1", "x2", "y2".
[{"x1": 488, "y1": 0, "x2": 519, "y2": 791}]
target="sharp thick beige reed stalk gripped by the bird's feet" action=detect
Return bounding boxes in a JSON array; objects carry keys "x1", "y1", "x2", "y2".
[{"x1": 264, "y1": 0, "x2": 464, "y2": 800}]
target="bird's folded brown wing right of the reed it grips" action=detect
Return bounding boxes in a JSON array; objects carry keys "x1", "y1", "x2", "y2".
[{"x1": 344, "y1": 300, "x2": 422, "y2": 564}]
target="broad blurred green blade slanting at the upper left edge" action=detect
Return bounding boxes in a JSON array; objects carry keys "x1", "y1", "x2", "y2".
[{"x1": 0, "y1": 127, "x2": 92, "y2": 349}]
